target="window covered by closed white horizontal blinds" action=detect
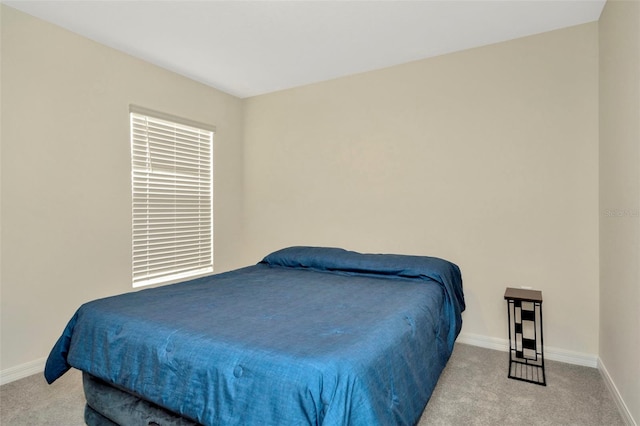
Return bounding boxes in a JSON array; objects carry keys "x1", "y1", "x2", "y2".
[{"x1": 130, "y1": 106, "x2": 215, "y2": 287}]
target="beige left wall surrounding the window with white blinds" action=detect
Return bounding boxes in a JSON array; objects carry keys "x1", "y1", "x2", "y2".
[{"x1": 0, "y1": 5, "x2": 243, "y2": 370}]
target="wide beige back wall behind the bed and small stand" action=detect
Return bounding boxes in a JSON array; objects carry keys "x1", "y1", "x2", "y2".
[{"x1": 244, "y1": 23, "x2": 598, "y2": 360}]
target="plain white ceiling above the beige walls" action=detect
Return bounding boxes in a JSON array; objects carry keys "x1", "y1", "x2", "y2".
[{"x1": 3, "y1": 0, "x2": 605, "y2": 98}]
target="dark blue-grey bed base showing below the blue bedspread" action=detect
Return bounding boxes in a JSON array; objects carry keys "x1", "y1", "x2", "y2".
[{"x1": 82, "y1": 372, "x2": 198, "y2": 426}]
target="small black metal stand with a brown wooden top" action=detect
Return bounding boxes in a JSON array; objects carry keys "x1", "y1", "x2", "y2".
[{"x1": 504, "y1": 288, "x2": 547, "y2": 386}]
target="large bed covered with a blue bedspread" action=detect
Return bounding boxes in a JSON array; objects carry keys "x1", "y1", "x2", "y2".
[{"x1": 44, "y1": 247, "x2": 465, "y2": 426}]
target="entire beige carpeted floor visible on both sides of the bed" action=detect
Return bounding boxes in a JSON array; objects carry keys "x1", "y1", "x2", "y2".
[{"x1": 0, "y1": 344, "x2": 624, "y2": 426}]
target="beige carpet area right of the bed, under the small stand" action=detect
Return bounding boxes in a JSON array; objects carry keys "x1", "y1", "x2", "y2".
[{"x1": 419, "y1": 344, "x2": 624, "y2": 426}]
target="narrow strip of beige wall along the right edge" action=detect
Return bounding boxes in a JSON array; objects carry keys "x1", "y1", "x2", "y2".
[{"x1": 599, "y1": 0, "x2": 640, "y2": 422}]
